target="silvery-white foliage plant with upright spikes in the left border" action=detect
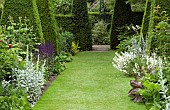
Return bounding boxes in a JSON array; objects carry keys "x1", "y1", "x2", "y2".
[{"x1": 13, "y1": 47, "x2": 45, "y2": 105}]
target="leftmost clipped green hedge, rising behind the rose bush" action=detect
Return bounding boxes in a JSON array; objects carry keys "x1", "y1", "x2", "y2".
[{"x1": 1, "y1": 0, "x2": 43, "y2": 38}]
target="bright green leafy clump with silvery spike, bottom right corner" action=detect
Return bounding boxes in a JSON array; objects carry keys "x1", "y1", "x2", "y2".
[{"x1": 139, "y1": 59, "x2": 170, "y2": 110}]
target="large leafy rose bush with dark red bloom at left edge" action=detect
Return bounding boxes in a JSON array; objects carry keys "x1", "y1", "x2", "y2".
[{"x1": 0, "y1": 17, "x2": 40, "y2": 79}]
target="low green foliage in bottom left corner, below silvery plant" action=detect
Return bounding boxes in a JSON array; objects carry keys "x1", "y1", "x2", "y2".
[{"x1": 0, "y1": 84, "x2": 31, "y2": 110}]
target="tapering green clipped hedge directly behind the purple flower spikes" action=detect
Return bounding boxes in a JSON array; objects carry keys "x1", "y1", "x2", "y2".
[{"x1": 36, "y1": 0, "x2": 58, "y2": 49}]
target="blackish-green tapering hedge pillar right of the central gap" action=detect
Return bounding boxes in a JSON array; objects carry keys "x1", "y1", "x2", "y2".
[{"x1": 110, "y1": 0, "x2": 132, "y2": 49}]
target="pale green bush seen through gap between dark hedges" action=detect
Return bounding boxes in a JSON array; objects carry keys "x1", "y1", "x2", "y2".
[{"x1": 92, "y1": 21, "x2": 109, "y2": 45}]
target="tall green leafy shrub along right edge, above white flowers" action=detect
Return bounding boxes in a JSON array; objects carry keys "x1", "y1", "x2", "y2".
[{"x1": 151, "y1": 9, "x2": 170, "y2": 57}]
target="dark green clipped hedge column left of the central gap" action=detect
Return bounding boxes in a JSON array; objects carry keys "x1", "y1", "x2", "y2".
[{"x1": 72, "y1": 0, "x2": 92, "y2": 50}]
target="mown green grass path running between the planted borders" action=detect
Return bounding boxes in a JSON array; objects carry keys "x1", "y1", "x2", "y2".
[{"x1": 33, "y1": 51, "x2": 146, "y2": 110}]
